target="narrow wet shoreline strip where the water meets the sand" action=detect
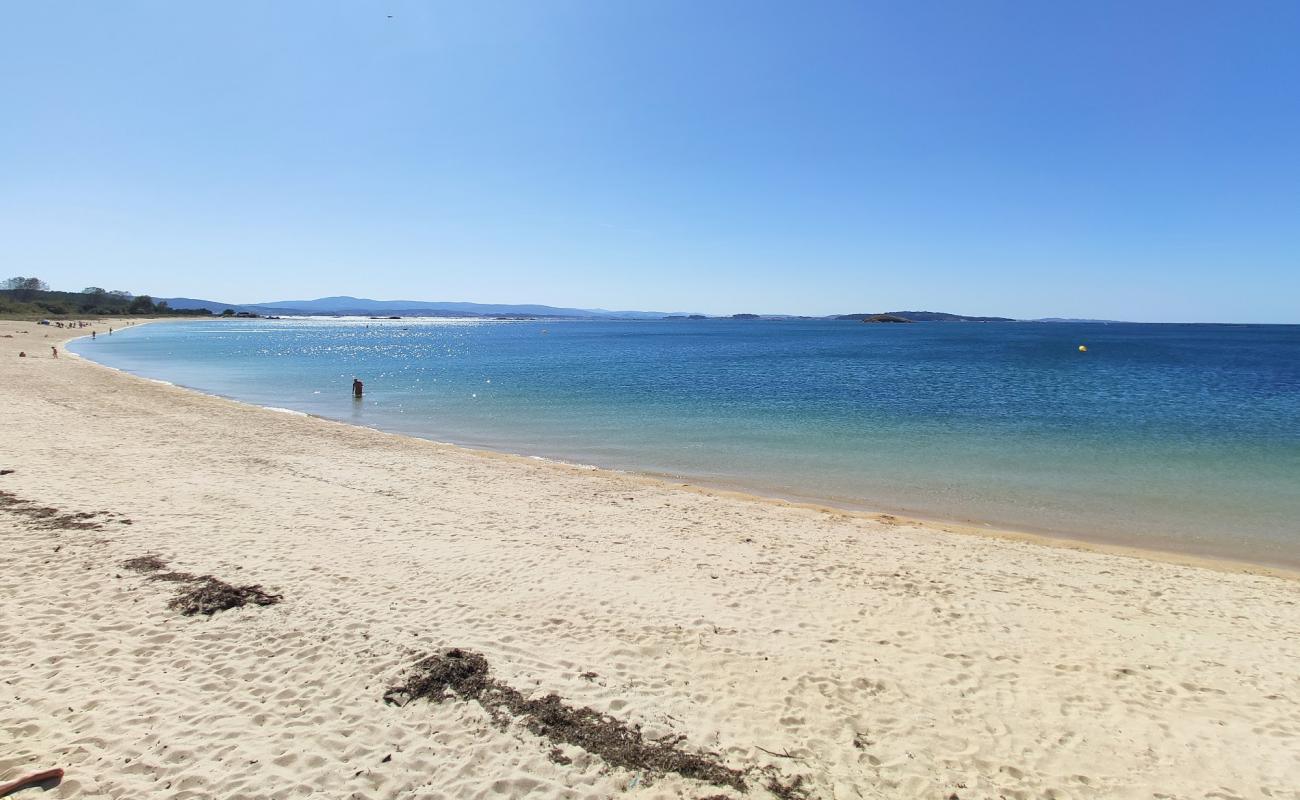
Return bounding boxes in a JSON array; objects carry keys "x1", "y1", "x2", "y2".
[{"x1": 64, "y1": 319, "x2": 1300, "y2": 580}]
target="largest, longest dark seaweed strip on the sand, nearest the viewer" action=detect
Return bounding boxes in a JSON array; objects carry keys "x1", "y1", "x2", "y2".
[{"x1": 384, "y1": 648, "x2": 746, "y2": 791}]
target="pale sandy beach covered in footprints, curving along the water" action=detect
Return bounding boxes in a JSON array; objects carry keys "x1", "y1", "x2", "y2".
[{"x1": 0, "y1": 321, "x2": 1300, "y2": 800}]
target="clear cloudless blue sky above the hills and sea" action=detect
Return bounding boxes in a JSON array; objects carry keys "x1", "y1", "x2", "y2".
[{"x1": 0, "y1": 0, "x2": 1300, "y2": 323}]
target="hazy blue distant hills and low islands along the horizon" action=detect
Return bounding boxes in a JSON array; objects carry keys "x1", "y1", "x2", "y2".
[{"x1": 166, "y1": 297, "x2": 1054, "y2": 323}]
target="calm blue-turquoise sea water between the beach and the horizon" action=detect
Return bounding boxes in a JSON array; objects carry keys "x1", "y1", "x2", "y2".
[{"x1": 73, "y1": 320, "x2": 1300, "y2": 566}]
